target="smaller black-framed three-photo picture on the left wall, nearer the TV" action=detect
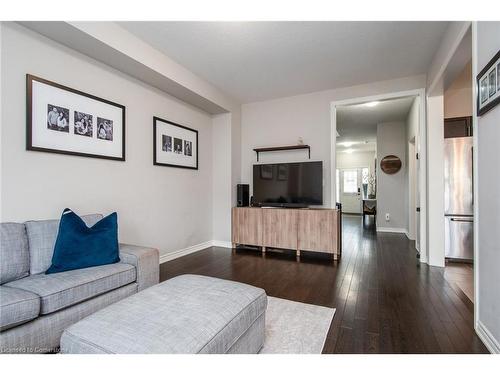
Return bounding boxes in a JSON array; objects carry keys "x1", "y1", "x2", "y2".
[{"x1": 153, "y1": 116, "x2": 198, "y2": 169}]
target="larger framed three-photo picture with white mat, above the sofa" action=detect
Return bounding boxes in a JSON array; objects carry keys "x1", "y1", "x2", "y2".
[{"x1": 26, "y1": 74, "x2": 125, "y2": 161}]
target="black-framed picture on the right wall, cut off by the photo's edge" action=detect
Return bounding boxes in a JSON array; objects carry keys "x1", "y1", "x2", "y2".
[{"x1": 476, "y1": 50, "x2": 500, "y2": 116}]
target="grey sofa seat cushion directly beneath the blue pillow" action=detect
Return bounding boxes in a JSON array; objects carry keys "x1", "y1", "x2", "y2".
[{"x1": 5, "y1": 263, "x2": 136, "y2": 315}]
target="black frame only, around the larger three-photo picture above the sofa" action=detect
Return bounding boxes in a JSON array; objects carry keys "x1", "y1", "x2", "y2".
[{"x1": 26, "y1": 74, "x2": 126, "y2": 161}]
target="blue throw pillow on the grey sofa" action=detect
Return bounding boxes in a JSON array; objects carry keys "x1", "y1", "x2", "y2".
[{"x1": 45, "y1": 208, "x2": 120, "y2": 274}]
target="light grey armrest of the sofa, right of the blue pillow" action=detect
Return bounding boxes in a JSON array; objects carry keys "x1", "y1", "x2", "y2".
[{"x1": 120, "y1": 244, "x2": 160, "y2": 292}]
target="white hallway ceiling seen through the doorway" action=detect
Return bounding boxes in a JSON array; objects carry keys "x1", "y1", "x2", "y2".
[{"x1": 337, "y1": 97, "x2": 415, "y2": 152}]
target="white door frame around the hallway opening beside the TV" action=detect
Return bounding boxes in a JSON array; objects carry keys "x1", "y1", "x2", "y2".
[{"x1": 330, "y1": 88, "x2": 428, "y2": 263}]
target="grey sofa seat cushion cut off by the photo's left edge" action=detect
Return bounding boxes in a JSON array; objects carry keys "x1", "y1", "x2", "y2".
[{"x1": 0, "y1": 285, "x2": 40, "y2": 331}]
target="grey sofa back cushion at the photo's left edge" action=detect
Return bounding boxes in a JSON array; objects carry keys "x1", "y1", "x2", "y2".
[{"x1": 0, "y1": 223, "x2": 30, "y2": 284}]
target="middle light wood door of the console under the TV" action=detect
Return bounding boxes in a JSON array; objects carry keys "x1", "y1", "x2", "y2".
[{"x1": 262, "y1": 208, "x2": 298, "y2": 250}]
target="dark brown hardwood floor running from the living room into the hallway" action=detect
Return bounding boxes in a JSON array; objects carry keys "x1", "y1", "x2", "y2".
[{"x1": 160, "y1": 215, "x2": 488, "y2": 353}]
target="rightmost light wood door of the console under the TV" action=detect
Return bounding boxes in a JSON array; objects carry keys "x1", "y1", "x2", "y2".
[{"x1": 298, "y1": 210, "x2": 337, "y2": 254}]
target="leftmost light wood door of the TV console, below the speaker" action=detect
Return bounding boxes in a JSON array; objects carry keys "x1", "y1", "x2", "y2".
[{"x1": 232, "y1": 207, "x2": 262, "y2": 246}]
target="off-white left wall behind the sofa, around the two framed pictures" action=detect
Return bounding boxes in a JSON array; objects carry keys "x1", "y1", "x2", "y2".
[{"x1": 1, "y1": 23, "x2": 212, "y2": 254}]
